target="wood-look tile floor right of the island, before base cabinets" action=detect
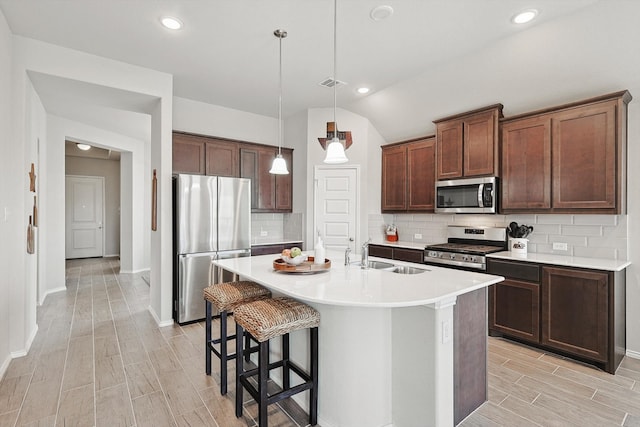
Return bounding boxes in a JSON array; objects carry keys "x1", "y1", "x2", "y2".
[{"x1": 460, "y1": 337, "x2": 640, "y2": 427}]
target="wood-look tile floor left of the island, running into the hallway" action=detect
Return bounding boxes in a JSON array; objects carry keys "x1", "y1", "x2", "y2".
[{"x1": 0, "y1": 258, "x2": 308, "y2": 427}]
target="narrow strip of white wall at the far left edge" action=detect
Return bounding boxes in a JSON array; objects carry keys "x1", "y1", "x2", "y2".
[{"x1": 0, "y1": 6, "x2": 13, "y2": 376}]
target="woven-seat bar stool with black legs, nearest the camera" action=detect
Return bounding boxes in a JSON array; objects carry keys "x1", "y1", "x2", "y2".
[{"x1": 234, "y1": 297, "x2": 320, "y2": 427}]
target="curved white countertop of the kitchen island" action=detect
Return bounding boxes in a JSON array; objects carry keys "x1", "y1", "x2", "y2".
[{"x1": 213, "y1": 251, "x2": 504, "y2": 308}]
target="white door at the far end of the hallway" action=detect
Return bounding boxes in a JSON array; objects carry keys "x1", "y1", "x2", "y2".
[{"x1": 65, "y1": 175, "x2": 104, "y2": 259}]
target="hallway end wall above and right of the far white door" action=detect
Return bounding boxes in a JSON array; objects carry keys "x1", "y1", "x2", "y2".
[{"x1": 65, "y1": 156, "x2": 120, "y2": 256}]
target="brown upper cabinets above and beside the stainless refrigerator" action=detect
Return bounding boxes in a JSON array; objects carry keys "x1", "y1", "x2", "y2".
[{"x1": 173, "y1": 132, "x2": 293, "y2": 212}]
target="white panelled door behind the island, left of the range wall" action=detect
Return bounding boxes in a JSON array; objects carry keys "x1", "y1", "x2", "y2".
[{"x1": 313, "y1": 167, "x2": 359, "y2": 251}]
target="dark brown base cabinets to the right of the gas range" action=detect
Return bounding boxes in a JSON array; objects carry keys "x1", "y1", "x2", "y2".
[{"x1": 487, "y1": 258, "x2": 626, "y2": 374}]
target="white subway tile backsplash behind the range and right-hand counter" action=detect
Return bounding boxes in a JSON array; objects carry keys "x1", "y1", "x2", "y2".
[{"x1": 368, "y1": 214, "x2": 628, "y2": 260}]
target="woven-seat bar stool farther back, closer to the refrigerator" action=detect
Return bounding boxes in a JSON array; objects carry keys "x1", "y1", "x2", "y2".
[{"x1": 204, "y1": 281, "x2": 271, "y2": 395}]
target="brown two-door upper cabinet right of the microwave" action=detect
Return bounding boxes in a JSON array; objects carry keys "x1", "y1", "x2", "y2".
[{"x1": 500, "y1": 91, "x2": 631, "y2": 214}]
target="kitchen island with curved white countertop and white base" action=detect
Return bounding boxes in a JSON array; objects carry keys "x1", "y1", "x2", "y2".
[{"x1": 214, "y1": 252, "x2": 503, "y2": 427}]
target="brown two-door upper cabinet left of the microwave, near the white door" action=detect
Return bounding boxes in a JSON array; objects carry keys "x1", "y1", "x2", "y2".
[{"x1": 381, "y1": 136, "x2": 435, "y2": 212}]
